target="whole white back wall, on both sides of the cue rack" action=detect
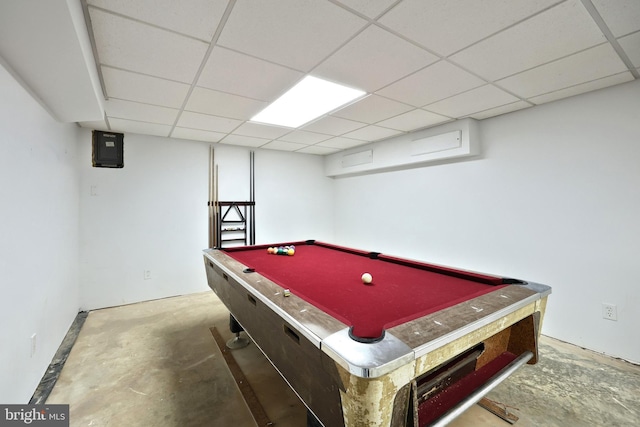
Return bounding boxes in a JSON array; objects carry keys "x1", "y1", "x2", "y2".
[{"x1": 78, "y1": 134, "x2": 333, "y2": 309}]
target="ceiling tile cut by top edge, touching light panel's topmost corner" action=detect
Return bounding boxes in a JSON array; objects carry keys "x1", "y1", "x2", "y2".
[{"x1": 218, "y1": 0, "x2": 367, "y2": 72}]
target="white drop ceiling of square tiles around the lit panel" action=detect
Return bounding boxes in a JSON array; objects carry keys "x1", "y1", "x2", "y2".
[{"x1": 3, "y1": 0, "x2": 640, "y2": 155}]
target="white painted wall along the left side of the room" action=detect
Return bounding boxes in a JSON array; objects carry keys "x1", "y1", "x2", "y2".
[{"x1": 0, "y1": 61, "x2": 80, "y2": 404}]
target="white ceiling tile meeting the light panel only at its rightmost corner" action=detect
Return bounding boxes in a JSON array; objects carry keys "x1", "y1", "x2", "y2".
[{"x1": 377, "y1": 61, "x2": 486, "y2": 107}]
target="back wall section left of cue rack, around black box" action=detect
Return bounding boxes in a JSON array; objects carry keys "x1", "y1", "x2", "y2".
[{"x1": 78, "y1": 129, "x2": 208, "y2": 309}]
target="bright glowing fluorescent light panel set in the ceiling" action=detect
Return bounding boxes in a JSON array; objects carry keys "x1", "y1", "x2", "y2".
[{"x1": 251, "y1": 76, "x2": 366, "y2": 128}]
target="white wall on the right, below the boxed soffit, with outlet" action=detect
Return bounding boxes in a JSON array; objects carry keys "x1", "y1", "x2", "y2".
[{"x1": 335, "y1": 81, "x2": 640, "y2": 363}]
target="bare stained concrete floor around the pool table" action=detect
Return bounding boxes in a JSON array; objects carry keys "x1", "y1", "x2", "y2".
[{"x1": 47, "y1": 292, "x2": 640, "y2": 427}]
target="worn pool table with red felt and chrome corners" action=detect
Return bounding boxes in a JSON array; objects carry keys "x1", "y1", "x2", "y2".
[{"x1": 204, "y1": 240, "x2": 551, "y2": 427}]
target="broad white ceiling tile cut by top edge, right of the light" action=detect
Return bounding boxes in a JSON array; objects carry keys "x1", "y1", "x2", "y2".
[{"x1": 379, "y1": 0, "x2": 558, "y2": 56}]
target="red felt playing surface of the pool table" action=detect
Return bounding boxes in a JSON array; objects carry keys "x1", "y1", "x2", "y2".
[{"x1": 225, "y1": 242, "x2": 505, "y2": 338}]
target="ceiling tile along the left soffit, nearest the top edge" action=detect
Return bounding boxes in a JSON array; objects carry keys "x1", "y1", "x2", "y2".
[{"x1": 89, "y1": 8, "x2": 207, "y2": 83}]
